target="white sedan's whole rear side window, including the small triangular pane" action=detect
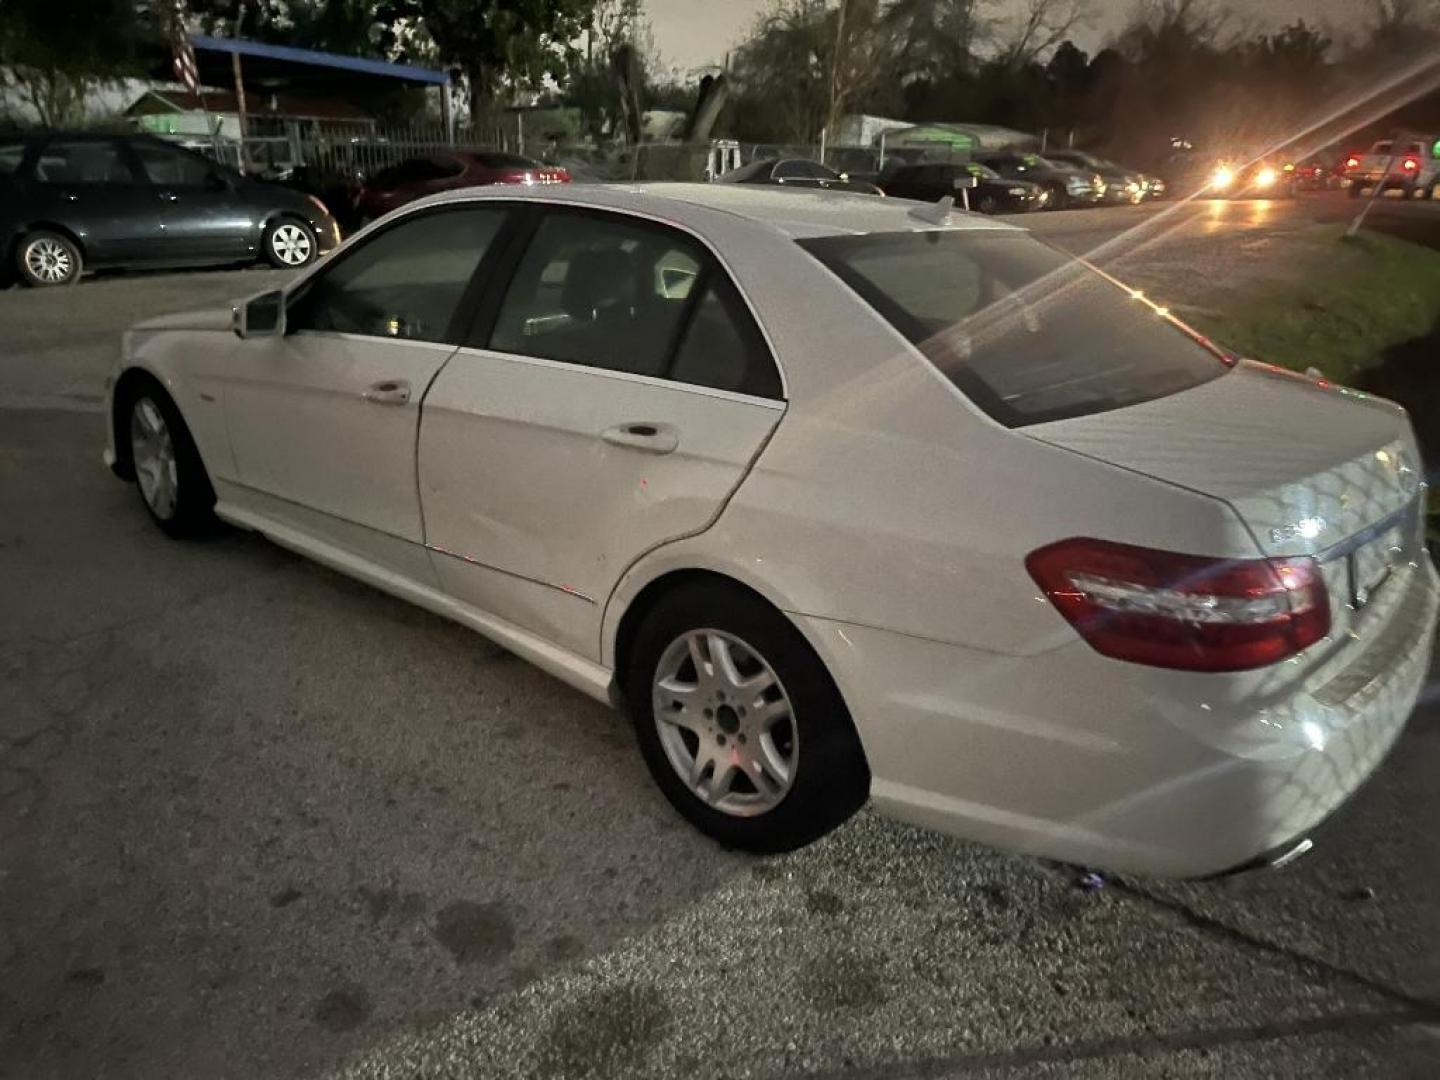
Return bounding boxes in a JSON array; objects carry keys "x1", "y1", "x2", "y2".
[{"x1": 487, "y1": 210, "x2": 779, "y2": 397}]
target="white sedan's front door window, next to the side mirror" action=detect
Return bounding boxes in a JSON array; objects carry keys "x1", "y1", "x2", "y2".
[{"x1": 288, "y1": 207, "x2": 505, "y2": 341}]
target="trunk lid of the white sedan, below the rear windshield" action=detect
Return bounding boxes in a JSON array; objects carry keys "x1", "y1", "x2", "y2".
[{"x1": 1024, "y1": 361, "x2": 1421, "y2": 556}]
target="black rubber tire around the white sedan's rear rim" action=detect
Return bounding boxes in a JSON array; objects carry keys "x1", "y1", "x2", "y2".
[{"x1": 624, "y1": 582, "x2": 870, "y2": 852}]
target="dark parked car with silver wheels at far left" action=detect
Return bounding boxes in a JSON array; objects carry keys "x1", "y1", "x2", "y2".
[{"x1": 0, "y1": 132, "x2": 340, "y2": 285}]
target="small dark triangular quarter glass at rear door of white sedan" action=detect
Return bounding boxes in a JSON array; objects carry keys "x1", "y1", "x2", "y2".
[{"x1": 671, "y1": 272, "x2": 780, "y2": 397}]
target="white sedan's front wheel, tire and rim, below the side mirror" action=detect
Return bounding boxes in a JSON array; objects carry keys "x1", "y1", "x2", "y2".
[{"x1": 127, "y1": 386, "x2": 215, "y2": 539}]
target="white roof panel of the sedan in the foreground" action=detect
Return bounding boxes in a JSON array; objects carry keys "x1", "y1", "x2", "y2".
[{"x1": 415, "y1": 183, "x2": 1024, "y2": 239}]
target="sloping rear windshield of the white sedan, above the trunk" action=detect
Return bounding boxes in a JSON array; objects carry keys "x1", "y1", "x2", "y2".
[{"x1": 799, "y1": 230, "x2": 1227, "y2": 428}]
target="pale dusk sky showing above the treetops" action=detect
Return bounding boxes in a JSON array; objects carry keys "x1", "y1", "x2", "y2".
[{"x1": 645, "y1": 0, "x2": 1361, "y2": 69}]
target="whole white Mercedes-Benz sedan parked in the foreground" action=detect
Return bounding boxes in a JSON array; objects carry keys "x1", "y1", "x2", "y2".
[{"x1": 107, "y1": 184, "x2": 1437, "y2": 876}]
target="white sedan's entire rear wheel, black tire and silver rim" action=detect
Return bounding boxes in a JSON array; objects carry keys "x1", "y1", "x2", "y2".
[{"x1": 625, "y1": 583, "x2": 870, "y2": 851}]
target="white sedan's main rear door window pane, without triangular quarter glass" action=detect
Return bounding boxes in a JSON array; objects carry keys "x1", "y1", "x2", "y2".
[{"x1": 490, "y1": 212, "x2": 706, "y2": 376}]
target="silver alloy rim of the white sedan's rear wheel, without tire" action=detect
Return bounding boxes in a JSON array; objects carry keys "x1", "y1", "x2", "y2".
[{"x1": 652, "y1": 629, "x2": 799, "y2": 818}]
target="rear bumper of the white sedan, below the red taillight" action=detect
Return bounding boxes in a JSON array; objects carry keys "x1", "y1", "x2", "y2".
[{"x1": 801, "y1": 560, "x2": 1440, "y2": 877}]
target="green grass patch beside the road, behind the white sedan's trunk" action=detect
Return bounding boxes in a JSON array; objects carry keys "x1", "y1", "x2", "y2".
[{"x1": 1187, "y1": 226, "x2": 1440, "y2": 386}]
